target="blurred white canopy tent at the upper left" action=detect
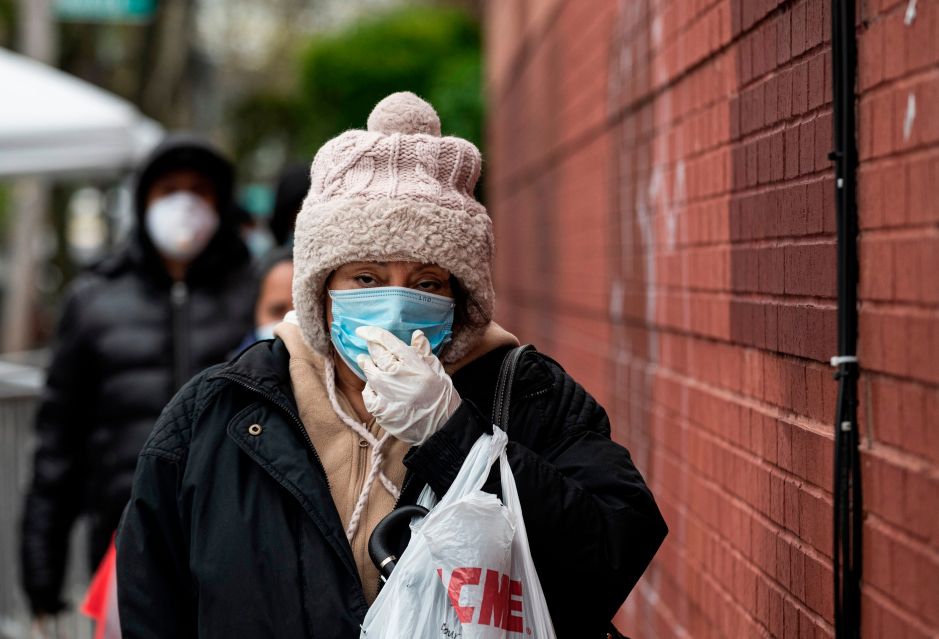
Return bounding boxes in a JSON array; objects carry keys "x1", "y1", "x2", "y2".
[{"x1": 0, "y1": 48, "x2": 163, "y2": 178}]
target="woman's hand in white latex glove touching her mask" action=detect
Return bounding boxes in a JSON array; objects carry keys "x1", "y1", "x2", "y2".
[{"x1": 355, "y1": 326, "x2": 461, "y2": 444}]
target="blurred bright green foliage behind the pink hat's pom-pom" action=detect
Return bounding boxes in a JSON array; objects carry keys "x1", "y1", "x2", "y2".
[{"x1": 298, "y1": 6, "x2": 483, "y2": 153}]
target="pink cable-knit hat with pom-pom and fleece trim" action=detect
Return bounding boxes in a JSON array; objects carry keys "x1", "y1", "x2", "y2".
[{"x1": 293, "y1": 92, "x2": 495, "y2": 362}]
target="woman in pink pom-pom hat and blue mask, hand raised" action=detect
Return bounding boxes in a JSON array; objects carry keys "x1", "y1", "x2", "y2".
[{"x1": 118, "y1": 93, "x2": 666, "y2": 638}]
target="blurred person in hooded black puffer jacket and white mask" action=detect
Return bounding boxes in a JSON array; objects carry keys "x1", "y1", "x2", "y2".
[{"x1": 21, "y1": 134, "x2": 255, "y2": 616}]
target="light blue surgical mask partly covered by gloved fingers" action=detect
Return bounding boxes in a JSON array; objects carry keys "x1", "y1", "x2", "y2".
[{"x1": 329, "y1": 286, "x2": 456, "y2": 380}]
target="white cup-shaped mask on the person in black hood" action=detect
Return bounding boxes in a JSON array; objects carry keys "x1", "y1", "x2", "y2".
[{"x1": 145, "y1": 191, "x2": 219, "y2": 260}]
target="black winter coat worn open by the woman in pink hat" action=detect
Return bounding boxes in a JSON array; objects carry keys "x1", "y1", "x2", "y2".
[{"x1": 118, "y1": 340, "x2": 666, "y2": 639}]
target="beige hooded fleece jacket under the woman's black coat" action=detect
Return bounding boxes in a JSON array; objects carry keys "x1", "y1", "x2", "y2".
[{"x1": 274, "y1": 322, "x2": 518, "y2": 604}]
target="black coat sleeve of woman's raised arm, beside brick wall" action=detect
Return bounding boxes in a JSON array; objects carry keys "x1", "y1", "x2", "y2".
[{"x1": 405, "y1": 353, "x2": 667, "y2": 637}]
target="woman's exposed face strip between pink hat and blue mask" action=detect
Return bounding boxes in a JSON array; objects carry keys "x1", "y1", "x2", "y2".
[{"x1": 326, "y1": 262, "x2": 453, "y2": 326}]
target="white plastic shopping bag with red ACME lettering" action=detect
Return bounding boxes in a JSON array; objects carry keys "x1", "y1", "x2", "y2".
[{"x1": 361, "y1": 428, "x2": 555, "y2": 639}]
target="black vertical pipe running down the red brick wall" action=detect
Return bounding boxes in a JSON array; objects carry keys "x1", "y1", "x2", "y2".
[{"x1": 831, "y1": 0, "x2": 863, "y2": 639}]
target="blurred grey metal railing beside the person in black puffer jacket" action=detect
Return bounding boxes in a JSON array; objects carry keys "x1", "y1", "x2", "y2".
[{"x1": 0, "y1": 352, "x2": 92, "y2": 639}]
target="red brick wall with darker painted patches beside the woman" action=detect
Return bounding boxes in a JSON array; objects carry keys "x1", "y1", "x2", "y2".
[{"x1": 486, "y1": 0, "x2": 939, "y2": 638}]
